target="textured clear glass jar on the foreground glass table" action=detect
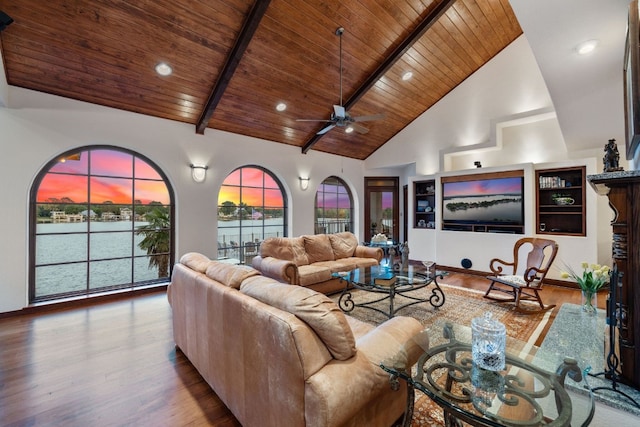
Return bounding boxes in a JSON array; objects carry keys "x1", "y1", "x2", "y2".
[{"x1": 471, "y1": 312, "x2": 507, "y2": 371}]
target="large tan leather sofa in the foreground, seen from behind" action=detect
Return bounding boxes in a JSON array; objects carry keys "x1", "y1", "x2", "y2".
[{"x1": 168, "y1": 253, "x2": 422, "y2": 427}]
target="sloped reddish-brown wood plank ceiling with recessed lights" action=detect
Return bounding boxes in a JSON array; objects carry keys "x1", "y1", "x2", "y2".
[{"x1": 0, "y1": 0, "x2": 522, "y2": 159}]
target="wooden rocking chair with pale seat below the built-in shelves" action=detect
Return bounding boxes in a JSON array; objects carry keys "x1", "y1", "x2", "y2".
[{"x1": 484, "y1": 237, "x2": 558, "y2": 313}]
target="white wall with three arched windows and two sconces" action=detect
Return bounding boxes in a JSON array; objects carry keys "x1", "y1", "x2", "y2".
[{"x1": 0, "y1": 87, "x2": 364, "y2": 312}]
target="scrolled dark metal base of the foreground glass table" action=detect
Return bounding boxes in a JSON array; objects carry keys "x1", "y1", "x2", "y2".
[{"x1": 381, "y1": 323, "x2": 595, "y2": 427}]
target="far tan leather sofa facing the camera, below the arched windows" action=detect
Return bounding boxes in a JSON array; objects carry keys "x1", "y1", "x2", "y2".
[{"x1": 252, "y1": 232, "x2": 384, "y2": 294}]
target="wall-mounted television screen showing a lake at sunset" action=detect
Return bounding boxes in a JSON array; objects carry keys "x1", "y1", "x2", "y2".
[{"x1": 442, "y1": 176, "x2": 524, "y2": 225}]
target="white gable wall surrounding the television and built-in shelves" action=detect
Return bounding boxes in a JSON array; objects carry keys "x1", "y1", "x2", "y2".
[{"x1": 365, "y1": 36, "x2": 608, "y2": 278}]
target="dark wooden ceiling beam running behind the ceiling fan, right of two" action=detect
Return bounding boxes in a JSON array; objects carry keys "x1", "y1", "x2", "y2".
[{"x1": 302, "y1": 0, "x2": 457, "y2": 154}]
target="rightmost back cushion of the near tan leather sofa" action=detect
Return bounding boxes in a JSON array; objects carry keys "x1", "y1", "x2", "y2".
[{"x1": 240, "y1": 278, "x2": 356, "y2": 360}]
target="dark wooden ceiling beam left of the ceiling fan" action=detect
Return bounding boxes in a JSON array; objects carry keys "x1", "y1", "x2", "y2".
[{"x1": 196, "y1": 0, "x2": 271, "y2": 135}]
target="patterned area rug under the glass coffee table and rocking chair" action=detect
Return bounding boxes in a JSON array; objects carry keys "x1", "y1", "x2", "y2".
[{"x1": 331, "y1": 283, "x2": 553, "y2": 427}]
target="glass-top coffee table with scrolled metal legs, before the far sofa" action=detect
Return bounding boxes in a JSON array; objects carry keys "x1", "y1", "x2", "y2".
[{"x1": 334, "y1": 264, "x2": 445, "y2": 318}]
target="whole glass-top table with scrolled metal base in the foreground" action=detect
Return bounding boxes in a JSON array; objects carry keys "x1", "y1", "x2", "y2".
[{"x1": 381, "y1": 320, "x2": 594, "y2": 426}]
